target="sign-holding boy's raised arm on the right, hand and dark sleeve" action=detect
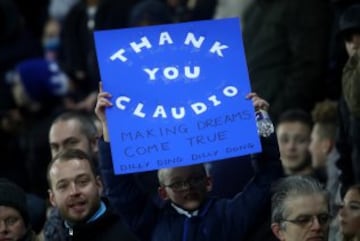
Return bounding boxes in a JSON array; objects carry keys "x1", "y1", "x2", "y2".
[{"x1": 224, "y1": 93, "x2": 283, "y2": 240}]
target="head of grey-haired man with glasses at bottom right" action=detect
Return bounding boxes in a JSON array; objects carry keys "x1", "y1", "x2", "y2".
[{"x1": 271, "y1": 176, "x2": 331, "y2": 241}]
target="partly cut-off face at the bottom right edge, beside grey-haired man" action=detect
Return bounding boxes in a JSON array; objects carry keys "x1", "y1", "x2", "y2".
[{"x1": 338, "y1": 188, "x2": 360, "y2": 238}]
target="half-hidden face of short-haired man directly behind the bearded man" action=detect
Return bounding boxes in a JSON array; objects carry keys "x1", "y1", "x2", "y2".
[{"x1": 49, "y1": 119, "x2": 97, "y2": 157}]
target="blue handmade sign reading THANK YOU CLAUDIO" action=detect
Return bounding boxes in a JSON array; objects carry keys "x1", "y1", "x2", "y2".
[{"x1": 95, "y1": 18, "x2": 261, "y2": 174}]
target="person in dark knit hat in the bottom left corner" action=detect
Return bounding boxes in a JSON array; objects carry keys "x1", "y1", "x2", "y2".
[{"x1": 0, "y1": 179, "x2": 38, "y2": 241}]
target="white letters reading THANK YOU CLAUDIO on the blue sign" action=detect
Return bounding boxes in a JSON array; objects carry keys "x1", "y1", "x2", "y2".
[{"x1": 109, "y1": 31, "x2": 239, "y2": 119}]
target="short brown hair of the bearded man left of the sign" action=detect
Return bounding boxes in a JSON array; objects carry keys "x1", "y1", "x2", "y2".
[{"x1": 47, "y1": 149, "x2": 98, "y2": 189}]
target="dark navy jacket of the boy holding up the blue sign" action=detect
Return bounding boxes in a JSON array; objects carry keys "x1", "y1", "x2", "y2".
[{"x1": 100, "y1": 135, "x2": 283, "y2": 241}]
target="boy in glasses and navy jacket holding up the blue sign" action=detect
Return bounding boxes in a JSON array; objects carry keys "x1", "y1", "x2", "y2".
[{"x1": 95, "y1": 88, "x2": 283, "y2": 241}]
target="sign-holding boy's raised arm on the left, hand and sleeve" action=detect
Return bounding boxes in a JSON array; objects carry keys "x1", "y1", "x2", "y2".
[{"x1": 95, "y1": 83, "x2": 157, "y2": 240}]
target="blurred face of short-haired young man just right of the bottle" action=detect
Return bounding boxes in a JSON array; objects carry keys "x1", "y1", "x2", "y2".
[{"x1": 276, "y1": 121, "x2": 311, "y2": 174}]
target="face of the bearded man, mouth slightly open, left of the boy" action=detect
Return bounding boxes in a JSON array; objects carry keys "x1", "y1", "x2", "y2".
[{"x1": 49, "y1": 159, "x2": 102, "y2": 223}]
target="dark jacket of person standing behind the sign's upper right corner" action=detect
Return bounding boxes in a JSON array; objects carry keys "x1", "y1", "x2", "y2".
[{"x1": 242, "y1": 0, "x2": 330, "y2": 123}]
